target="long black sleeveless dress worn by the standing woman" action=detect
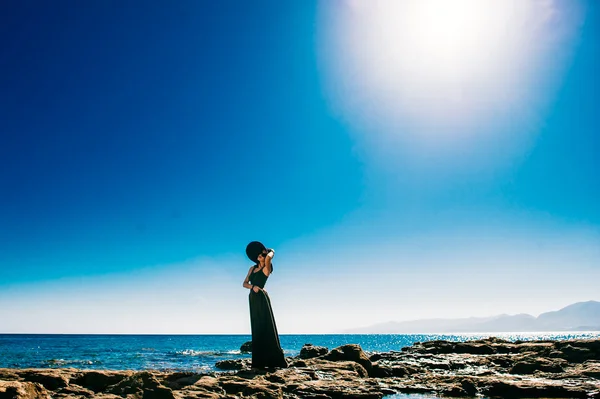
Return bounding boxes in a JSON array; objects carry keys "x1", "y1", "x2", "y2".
[{"x1": 249, "y1": 265, "x2": 287, "y2": 368}]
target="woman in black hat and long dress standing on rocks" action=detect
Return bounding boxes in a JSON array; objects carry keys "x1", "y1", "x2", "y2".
[{"x1": 243, "y1": 241, "x2": 287, "y2": 368}]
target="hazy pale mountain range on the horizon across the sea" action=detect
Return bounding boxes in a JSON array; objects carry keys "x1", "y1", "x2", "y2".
[{"x1": 344, "y1": 301, "x2": 600, "y2": 334}]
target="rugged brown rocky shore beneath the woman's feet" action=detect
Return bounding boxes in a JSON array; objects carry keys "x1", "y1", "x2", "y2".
[{"x1": 0, "y1": 338, "x2": 600, "y2": 399}]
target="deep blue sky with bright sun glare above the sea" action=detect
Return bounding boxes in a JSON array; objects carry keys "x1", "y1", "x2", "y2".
[{"x1": 0, "y1": 0, "x2": 600, "y2": 333}]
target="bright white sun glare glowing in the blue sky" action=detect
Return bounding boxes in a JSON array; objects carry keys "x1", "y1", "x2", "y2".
[{"x1": 320, "y1": 0, "x2": 574, "y2": 155}]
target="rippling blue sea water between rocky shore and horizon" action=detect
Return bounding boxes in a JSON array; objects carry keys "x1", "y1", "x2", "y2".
[{"x1": 0, "y1": 332, "x2": 600, "y2": 372}]
